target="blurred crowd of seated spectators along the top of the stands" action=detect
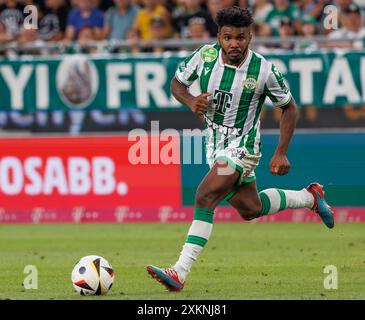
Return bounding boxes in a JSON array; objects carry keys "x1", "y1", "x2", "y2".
[{"x1": 0, "y1": 0, "x2": 365, "y2": 52}]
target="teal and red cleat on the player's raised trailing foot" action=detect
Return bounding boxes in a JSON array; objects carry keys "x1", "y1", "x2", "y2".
[{"x1": 307, "y1": 182, "x2": 335, "y2": 229}]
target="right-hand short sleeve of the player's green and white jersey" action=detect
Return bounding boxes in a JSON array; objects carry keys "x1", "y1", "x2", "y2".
[{"x1": 264, "y1": 64, "x2": 292, "y2": 107}]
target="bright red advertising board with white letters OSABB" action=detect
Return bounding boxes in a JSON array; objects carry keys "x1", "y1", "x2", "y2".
[{"x1": 0, "y1": 136, "x2": 181, "y2": 211}]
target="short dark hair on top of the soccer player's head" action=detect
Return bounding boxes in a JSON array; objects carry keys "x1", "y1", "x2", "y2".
[{"x1": 216, "y1": 6, "x2": 254, "y2": 29}]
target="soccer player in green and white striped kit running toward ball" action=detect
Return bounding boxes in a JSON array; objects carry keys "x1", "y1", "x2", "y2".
[{"x1": 147, "y1": 7, "x2": 334, "y2": 291}]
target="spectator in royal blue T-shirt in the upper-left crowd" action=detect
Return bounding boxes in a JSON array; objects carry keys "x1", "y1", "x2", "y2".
[{"x1": 65, "y1": 0, "x2": 104, "y2": 42}]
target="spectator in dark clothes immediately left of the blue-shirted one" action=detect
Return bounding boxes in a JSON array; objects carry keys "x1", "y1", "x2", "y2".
[{"x1": 38, "y1": 0, "x2": 69, "y2": 41}]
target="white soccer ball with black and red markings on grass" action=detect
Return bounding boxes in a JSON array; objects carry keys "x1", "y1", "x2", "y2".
[{"x1": 71, "y1": 255, "x2": 114, "y2": 296}]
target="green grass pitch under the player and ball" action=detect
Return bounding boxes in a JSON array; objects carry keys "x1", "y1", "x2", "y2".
[{"x1": 0, "y1": 223, "x2": 365, "y2": 300}]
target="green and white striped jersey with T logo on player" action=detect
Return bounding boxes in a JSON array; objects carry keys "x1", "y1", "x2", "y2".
[{"x1": 175, "y1": 43, "x2": 291, "y2": 153}]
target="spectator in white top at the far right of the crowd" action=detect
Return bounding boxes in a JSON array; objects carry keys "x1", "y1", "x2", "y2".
[{"x1": 328, "y1": 3, "x2": 365, "y2": 49}]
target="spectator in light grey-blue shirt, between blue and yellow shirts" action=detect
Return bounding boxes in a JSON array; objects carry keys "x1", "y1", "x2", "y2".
[{"x1": 103, "y1": 0, "x2": 139, "y2": 39}]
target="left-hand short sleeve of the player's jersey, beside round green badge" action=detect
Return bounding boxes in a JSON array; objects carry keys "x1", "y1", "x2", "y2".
[{"x1": 175, "y1": 46, "x2": 203, "y2": 87}]
